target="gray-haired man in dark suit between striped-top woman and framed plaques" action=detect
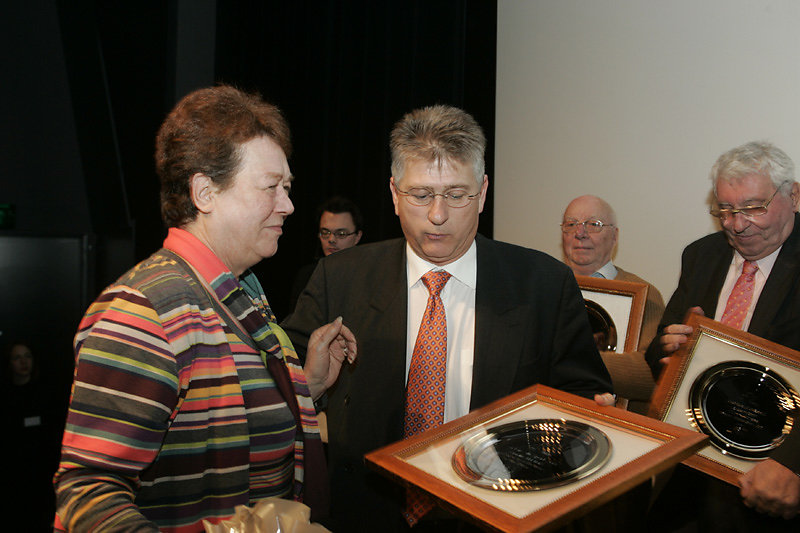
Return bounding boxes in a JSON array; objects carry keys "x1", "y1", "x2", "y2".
[{"x1": 284, "y1": 106, "x2": 613, "y2": 531}]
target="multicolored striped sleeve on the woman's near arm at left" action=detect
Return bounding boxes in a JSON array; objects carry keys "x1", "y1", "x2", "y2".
[{"x1": 55, "y1": 286, "x2": 179, "y2": 531}]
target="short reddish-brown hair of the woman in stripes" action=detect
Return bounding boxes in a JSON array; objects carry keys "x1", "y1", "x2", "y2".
[{"x1": 155, "y1": 85, "x2": 292, "y2": 227}]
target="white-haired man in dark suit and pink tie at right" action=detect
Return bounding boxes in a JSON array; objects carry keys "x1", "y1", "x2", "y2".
[{"x1": 645, "y1": 142, "x2": 800, "y2": 530}]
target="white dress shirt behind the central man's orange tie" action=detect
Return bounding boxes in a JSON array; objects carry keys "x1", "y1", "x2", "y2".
[{"x1": 406, "y1": 241, "x2": 478, "y2": 422}]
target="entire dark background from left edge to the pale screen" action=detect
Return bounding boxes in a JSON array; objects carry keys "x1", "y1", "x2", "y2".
[{"x1": 0, "y1": 0, "x2": 497, "y2": 390}]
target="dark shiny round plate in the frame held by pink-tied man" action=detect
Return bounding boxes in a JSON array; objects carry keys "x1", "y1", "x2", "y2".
[{"x1": 689, "y1": 361, "x2": 800, "y2": 459}]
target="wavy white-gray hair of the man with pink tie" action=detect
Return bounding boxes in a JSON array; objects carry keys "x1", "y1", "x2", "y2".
[{"x1": 709, "y1": 141, "x2": 795, "y2": 196}]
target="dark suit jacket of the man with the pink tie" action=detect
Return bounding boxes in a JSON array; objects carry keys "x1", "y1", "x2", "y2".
[{"x1": 645, "y1": 214, "x2": 800, "y2": 472}]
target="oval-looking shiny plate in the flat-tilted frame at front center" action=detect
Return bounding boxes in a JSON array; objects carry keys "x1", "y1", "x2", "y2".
[{"x1": 452, "y1": 419, "x2": 611, "y2": 491}]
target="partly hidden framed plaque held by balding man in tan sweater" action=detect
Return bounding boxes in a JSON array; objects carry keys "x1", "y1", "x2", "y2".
[{"x1": 575, "y1": 276, "x2": 647, "y2": 353}]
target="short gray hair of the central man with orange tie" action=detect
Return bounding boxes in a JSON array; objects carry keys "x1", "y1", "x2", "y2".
[{"x1": 390, "y1": 105, "x2": 486, "y2": 184}]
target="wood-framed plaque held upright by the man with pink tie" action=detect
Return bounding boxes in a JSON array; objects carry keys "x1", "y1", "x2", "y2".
[{"x1": 650, "y1": 314, "x2": 800, "y2": 485}]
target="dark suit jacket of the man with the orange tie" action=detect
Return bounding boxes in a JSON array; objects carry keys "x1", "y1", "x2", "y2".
[{"x1": 283, "y1": 236, "x2": 611, "y2": 531}]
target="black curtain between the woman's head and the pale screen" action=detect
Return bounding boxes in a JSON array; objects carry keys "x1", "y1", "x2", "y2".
[{"x1": 216, "y1": 0, "x2": 497, "y2": 316}]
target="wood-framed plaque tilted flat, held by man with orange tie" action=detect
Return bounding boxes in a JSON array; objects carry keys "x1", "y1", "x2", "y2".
[{"x1": 366, "y1": 385, "x2": 708, "y2": 532}]
